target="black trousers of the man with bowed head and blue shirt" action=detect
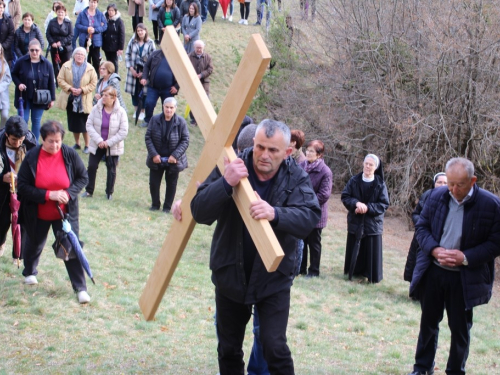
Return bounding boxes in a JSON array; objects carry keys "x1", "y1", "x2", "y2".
[{"x1": 413, "y1": 264, "x2": 472, "y2": 374}]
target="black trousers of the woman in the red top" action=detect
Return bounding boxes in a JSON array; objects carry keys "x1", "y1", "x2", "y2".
[{"x1": 23, "y1": 219, "x2": 87, "y2": 292}]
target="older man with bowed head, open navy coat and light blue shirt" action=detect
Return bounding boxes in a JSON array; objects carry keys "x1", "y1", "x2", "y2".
[{"x1": 410, "y1": 158, "x2": 500, "y2": 375}]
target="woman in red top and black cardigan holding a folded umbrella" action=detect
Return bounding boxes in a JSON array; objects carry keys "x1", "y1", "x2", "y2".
[{"x1": 17, "y1": 121, "x2": 90, "y2": 303}]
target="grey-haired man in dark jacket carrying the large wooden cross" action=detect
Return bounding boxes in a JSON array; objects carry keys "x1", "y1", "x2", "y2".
[{"x1": 191, "y1": 120, "x2": 321, "y2": 375}]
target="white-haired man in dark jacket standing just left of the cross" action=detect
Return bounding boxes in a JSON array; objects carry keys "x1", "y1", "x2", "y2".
[{"x1": 145, "y1": 97, "x2": 189, "y2": 213}]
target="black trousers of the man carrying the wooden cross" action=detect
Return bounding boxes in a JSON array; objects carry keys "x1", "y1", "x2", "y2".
[{"x1": 215, "y1": 289, "x2": 294, "y2": 375}]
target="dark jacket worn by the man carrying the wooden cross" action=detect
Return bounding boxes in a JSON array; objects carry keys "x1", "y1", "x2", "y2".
[{"x1": 191, "y1": 148, "x2": 321, "y2": 304}]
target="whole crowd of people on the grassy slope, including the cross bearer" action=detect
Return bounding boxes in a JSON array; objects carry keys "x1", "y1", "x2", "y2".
[{"x1": 0, "y1": 0, "x2": 500, "y2": 375}]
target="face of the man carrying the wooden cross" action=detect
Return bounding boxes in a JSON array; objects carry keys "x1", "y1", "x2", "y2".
[{"x1": 253, "y1": 129, "x2": 292, "y2": 181}]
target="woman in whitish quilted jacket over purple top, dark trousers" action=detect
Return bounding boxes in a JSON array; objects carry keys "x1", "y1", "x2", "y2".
[{"x1": 82, "y1": 86, "x2": 128, "y2": 200}]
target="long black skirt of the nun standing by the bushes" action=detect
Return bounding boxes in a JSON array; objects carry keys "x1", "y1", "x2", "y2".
[{"x1": 344, "y1": 233, "x2": 383, "y2": 284}]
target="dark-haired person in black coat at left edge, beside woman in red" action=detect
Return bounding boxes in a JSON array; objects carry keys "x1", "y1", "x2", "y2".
[{"x1": 0, "y1": 116, "x2": 37, "y2": 259}]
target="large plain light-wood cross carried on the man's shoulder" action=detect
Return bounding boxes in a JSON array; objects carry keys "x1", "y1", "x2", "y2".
[{"x1": 139, "y1": 26, "x2": 284, "y2": 320}]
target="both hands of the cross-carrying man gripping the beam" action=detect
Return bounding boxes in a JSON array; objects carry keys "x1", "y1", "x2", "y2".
[{"x1": 224, "y1": 157, "x2": 275, "y2": 221}]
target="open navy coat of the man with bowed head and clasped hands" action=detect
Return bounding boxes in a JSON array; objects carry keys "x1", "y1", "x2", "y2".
[{"x1": 410, "y1": 185, "x2": 500, "y2": 309}]
